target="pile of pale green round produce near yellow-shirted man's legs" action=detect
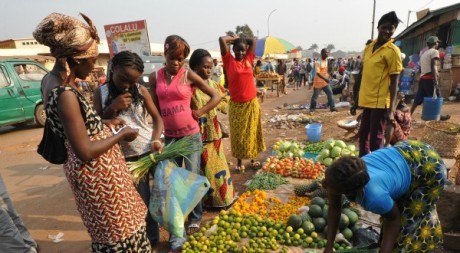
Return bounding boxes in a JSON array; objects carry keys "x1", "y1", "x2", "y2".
[{"x1": 316, "y1": 139, "x2": 359, "y2": 166}]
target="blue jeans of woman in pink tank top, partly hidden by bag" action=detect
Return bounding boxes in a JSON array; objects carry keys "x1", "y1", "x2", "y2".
[{"x1": 165, "y1": 133, "x2": 203, "y2": 249}]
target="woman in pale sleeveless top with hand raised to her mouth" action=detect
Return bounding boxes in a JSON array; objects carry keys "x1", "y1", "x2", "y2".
[{"x1": 93, "y1": 51, "x2": 163, "y2": 245}]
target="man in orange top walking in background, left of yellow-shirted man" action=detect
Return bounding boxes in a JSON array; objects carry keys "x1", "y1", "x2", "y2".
[{"x1": 310, "y1": 48, "x2": 337, "y2": 112}]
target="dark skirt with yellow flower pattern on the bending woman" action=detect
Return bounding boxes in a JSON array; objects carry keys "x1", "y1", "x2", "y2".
[{"x1": 394, "y1": 140, "x2": 447, "y2": 252}]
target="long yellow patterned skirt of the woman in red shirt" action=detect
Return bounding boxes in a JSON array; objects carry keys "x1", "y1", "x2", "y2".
[{"x1": 228, "y1": 98, "x2": 265, "y2": 159}]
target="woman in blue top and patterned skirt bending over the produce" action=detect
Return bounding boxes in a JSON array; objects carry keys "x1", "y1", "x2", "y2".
[{"x1": 323, "y1": 140, "x2": 446, "y2": 252}]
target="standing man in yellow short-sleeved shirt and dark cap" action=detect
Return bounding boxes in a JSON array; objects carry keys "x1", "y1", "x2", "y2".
[{"x1": 358, "y1": 11, "x2": 403, "y2": 156}]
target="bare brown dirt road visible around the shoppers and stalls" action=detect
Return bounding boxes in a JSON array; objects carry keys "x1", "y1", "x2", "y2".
[{"x1": 0, "y1": 84, "x2": 460, "y2": 253}]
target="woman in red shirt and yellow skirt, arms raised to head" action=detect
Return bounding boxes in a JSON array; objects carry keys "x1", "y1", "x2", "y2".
[{"x1": 219, "y1": 35, "x2": 265, "y2": 171}]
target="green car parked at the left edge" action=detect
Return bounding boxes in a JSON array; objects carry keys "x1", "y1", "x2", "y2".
[{"x1": 0, "y1": 59, "x2": 48, "y2": 127}]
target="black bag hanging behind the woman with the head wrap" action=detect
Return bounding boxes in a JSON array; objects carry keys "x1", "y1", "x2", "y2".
[{"x1": 37, "y1": 120, "x2": 67, "y2": 164}]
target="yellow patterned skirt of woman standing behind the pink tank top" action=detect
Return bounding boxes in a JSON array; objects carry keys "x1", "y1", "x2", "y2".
[{"x1": 201, "y1": 139, "x2": 235, "y2": 207}]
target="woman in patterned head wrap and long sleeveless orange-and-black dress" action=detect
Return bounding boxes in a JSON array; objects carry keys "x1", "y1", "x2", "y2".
[{"x1": 34, "y1": 13, "x2": 151, "y2": 252}]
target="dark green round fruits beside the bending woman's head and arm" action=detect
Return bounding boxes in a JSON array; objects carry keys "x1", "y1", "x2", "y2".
[{"x1": 287, "y1": 197, "x2": 359, "y2": 241}]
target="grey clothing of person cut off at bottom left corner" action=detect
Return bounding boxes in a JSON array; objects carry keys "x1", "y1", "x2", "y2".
[{"x1": 0, "y1": 176, "x2": 37, "y2": 253}]
